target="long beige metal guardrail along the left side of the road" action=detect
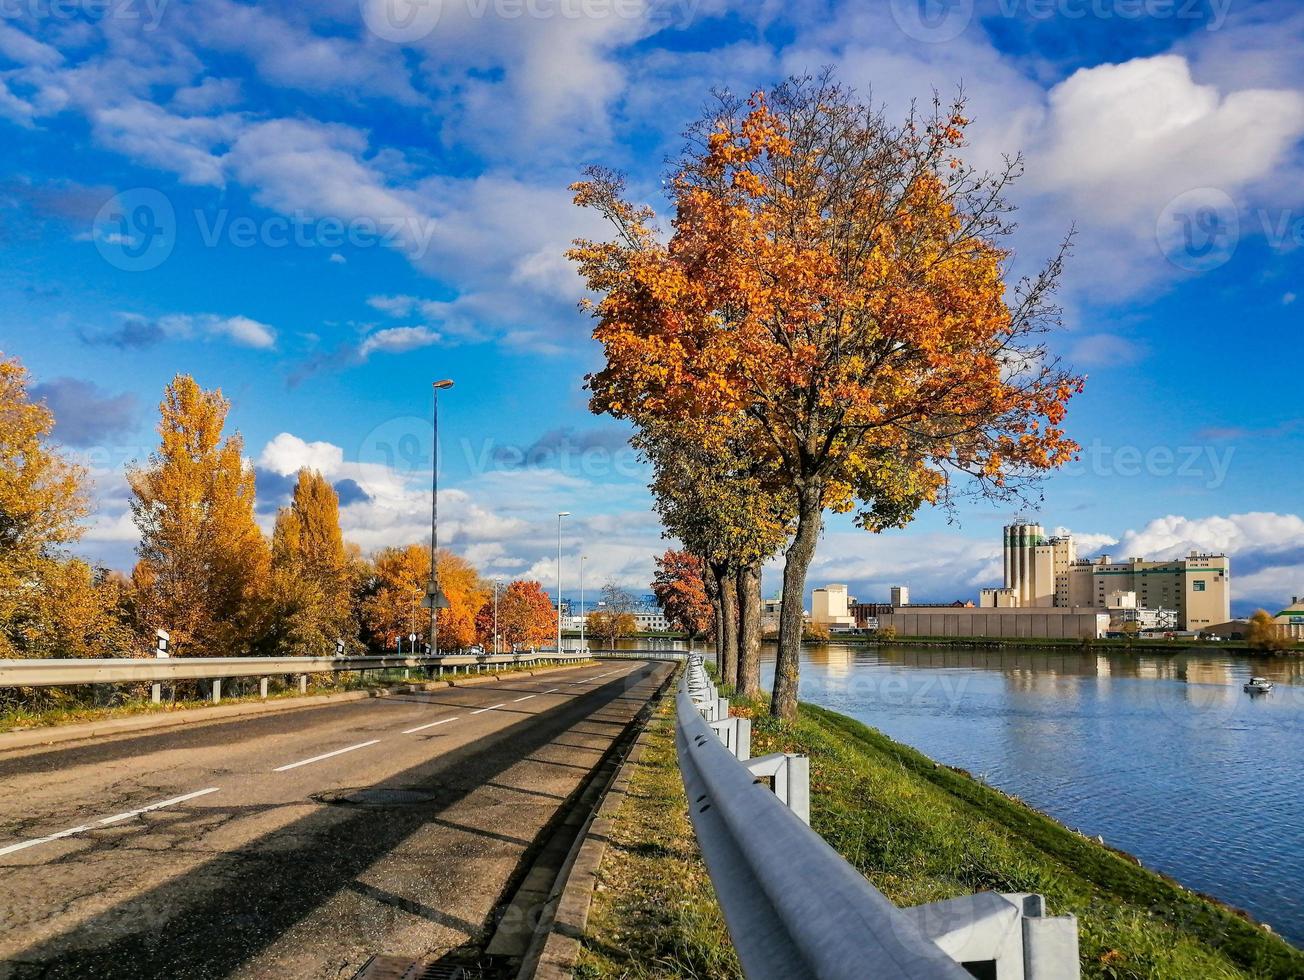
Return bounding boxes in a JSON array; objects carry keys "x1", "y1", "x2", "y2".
[{"x1": 0, "y1": 650, "x2": 588, "y2": 700}]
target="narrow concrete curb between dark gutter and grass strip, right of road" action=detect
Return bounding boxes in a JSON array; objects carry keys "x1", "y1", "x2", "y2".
[{"x1": 516, "y1": 670, "x2": 679, "y2": 980}]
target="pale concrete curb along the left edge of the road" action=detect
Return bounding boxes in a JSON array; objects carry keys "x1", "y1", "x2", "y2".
[{"x1": 0, "y1": 663, "x2": 593, "y2": 755}]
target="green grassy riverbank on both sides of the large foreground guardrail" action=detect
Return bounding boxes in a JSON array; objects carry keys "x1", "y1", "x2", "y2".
[{"x1": 576, "y1": 682, "x2": 1304, "y2": 980}]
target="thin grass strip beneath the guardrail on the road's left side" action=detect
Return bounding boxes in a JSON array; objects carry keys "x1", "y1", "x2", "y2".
[{"x1": 0, "y1": 661, "x2": 596, "y2": 732}]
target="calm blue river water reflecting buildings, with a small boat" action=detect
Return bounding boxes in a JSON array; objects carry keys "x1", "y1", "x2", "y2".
[{"x1": 745, "y1": 645, "x2": 1304, "y2": 945}]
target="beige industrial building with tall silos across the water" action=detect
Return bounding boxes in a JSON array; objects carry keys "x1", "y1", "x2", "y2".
[{"x1": 978, "y1": 521, "x2": 1231, "y2": 631}]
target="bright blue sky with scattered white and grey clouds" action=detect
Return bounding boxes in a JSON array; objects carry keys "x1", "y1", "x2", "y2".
[{"x1": 0, "y1": 0, "x2": 1304, "y2": 610}]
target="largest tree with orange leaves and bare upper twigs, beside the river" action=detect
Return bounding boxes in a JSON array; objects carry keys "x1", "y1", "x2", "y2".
[{"x1": 570, "y1": 74, "x2": 1081, "y2": 719}]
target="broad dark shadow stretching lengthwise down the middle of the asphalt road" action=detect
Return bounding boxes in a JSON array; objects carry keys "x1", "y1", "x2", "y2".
[{"x1": 0, "y1": 665, "x2": 665, "y2": 980}]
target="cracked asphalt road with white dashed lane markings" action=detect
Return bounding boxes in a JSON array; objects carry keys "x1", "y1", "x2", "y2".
[{"x1": 0, "y1": 662, "x2": 670, "y2": 977}]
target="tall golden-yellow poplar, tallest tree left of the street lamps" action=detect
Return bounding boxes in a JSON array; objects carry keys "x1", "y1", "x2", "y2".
[{"x1": 126, "y1": 374, "x2": 270, "y2": 657}]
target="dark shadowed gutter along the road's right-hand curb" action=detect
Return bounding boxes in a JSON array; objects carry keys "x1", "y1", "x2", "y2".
[{"x1": 352, "y1": 662, "x2": 674, "y2": 980}]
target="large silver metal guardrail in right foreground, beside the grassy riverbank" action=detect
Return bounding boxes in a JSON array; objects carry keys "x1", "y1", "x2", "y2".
[{"x1": 675, "y1": 656, "x2": 1080, "y2": 980}]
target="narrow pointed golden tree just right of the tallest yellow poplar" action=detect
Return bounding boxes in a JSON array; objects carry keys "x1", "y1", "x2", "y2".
[{"x1": 269, "y1": 469, "x2": 356, "y2": 656}]
